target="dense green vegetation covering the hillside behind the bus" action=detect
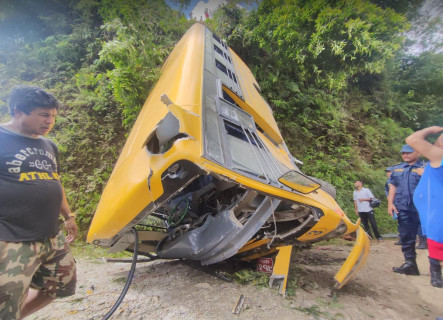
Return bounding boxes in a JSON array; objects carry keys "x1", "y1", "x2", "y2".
[{"x1": 0, "y1": 0, "x2": 443, "y2": 233}]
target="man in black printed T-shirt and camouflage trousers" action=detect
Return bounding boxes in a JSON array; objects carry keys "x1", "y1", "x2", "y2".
[{"x1": 0, "y1": 86, "x2": 78, "y2": 320}]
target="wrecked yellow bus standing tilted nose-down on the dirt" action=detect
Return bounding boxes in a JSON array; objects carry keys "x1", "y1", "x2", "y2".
[{"x1": 87, "y1": 23, "x2": 369, "y2": 289}]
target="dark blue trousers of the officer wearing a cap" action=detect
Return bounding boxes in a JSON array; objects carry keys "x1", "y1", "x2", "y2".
[{"x1": 398, "y1": 210, "x2": 420, "y2": 260}]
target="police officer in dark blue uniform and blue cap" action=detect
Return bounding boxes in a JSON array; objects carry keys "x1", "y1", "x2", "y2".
[{"x1": 388, "y1": 144, "x2": 424, "y2": 276}]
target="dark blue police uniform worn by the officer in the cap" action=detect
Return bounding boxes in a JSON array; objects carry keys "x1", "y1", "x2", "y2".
[{"x1": 389, "y1": 160, "x2": 424, "y2": 261}]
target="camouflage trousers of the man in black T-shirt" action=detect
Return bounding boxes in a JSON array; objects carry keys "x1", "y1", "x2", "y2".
[{"x1": 0, "y1": 232, "x2": 77, "y2": 320}]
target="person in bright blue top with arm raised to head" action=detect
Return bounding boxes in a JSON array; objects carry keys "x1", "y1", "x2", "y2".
[{"x1": 406, "y1": 126, "x2": 443, "y2": 288}]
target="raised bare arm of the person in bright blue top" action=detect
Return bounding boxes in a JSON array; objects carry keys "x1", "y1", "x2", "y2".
[{"x1": 406, "y1": 126, "x2": 443, "y2": 168}]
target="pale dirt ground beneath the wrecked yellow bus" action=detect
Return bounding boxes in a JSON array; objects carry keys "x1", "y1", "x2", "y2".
[{"x1": 28, "y1": 239, "x2": 443, "y2": 320}]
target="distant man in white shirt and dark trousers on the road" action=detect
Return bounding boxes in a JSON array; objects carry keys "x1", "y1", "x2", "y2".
[{"x1": 353, "y1": 180, "x2": 383, "y2": 241}]
